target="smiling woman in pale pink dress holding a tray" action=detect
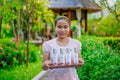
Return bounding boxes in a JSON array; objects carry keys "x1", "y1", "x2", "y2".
[{"x1": 42, "y1": 16, "x2": 84, "y2": 80}]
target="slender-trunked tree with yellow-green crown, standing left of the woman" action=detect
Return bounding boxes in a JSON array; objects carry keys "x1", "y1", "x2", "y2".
[{"x1": 22, "y1": 0, "x2": 52, "y2": 66}]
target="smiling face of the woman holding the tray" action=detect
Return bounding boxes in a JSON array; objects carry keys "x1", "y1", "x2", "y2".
[{"x1": 55, "y1": 19, "x2": 70, "y2": 38}]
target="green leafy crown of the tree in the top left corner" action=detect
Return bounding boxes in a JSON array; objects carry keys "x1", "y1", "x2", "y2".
[{"x1": 0, "y1": 0, "x2": 22, "y2": 23}]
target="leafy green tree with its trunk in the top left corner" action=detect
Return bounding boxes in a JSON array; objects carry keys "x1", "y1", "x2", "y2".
[{"x1": 0, "y1": 0, "x2": 22, "y2": 37}]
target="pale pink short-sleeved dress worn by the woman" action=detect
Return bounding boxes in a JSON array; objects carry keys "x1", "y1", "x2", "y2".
[{"x1": 43, "y1": 38, "x2": 81, "y2": 80}]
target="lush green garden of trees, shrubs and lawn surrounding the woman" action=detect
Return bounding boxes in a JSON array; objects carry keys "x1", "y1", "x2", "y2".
[{"x1": 0, "y1": 0, "x2": 120, "y2": 80}]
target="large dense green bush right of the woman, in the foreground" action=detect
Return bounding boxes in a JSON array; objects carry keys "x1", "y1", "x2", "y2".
[{"x1": 77, "y1": 36, "x2": 120, "y2": 80}]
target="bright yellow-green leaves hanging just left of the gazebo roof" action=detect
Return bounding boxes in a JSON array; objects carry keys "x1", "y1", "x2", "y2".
[{"x1": 30, "y1": 0, "x2": 54, "y2": 31}]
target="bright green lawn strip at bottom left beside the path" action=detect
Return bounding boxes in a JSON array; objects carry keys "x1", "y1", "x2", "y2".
[{"x1": 0, "y1": 61, "x2": 42, "y2": 80}]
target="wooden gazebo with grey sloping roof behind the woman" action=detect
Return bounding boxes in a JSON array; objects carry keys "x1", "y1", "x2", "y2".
[{"x1": 49, "y1": 0, "x2": 101, "y2": 36}]
